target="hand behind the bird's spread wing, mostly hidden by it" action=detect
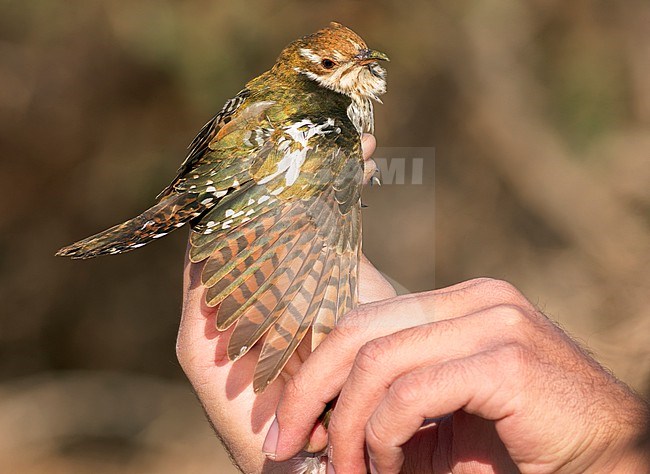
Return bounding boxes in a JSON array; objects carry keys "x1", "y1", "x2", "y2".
[{"x1": 177, "y1": 131, "x2": 395, "y2": 472}]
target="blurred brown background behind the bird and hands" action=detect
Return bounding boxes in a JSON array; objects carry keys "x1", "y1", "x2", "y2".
[{"x1": 0, "y1": 0, "x2": 650, "y2": 473}]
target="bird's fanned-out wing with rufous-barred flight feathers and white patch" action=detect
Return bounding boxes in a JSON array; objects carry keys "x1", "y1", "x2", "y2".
[{"x1": 184, "y1": 101, "x2": 363, "y2": 391}]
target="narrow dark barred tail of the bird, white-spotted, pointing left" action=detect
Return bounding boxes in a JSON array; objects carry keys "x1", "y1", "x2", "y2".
[{"x1": 56, "y1": 194, "x2": 204, "y2": 258}]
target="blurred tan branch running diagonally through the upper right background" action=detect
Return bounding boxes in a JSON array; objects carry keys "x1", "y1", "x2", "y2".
[{"x1": 462, "y1": 5, "x2": 650, "y2": 279}]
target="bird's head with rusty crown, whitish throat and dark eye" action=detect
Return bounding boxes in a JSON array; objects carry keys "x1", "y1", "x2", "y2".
[{"x1": 275, "y1": 22, "x2": 388, "y2": 102}]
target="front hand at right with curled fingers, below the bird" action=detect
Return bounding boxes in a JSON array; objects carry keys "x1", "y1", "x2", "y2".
[{"x1": 275, "y1": 279, "x2": 650, "y2": 473}]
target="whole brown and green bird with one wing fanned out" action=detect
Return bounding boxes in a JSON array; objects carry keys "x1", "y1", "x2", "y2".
[{"x1": 56, "y1": 22, "x2": 388, "y2": 393}]
